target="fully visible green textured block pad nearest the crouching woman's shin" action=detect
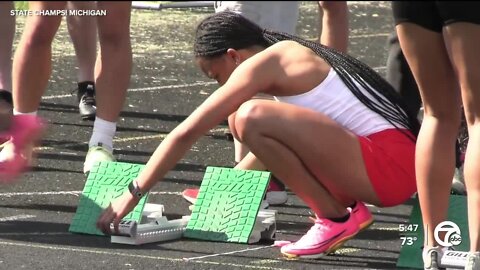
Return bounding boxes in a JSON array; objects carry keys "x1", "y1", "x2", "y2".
[{"x1": 184, "y1": 167, "x2": 270, "y2": 243}]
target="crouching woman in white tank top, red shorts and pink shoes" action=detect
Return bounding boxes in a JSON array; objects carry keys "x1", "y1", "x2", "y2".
[{"x1": 98, "y1": 12, "x2": 419, "y2": 257}]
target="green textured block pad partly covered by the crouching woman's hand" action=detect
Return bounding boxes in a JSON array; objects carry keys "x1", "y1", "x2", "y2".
[{"x1": 68, "y1": 162, "x2": 148, "y2": 235}]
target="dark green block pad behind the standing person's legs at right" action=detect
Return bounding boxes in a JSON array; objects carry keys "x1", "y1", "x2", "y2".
[{"x1": 397, "y1": 195, "x2": 470, "y2": 269}]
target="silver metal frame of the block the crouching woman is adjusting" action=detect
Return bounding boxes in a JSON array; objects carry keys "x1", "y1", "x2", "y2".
[{"x1": 110, "y1": 203, "x2": 277, "y2": 245}]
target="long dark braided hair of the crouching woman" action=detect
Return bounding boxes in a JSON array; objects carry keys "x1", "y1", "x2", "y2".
[{"x1": 194, "y1": 11, "x2": 420, "y2": 141}]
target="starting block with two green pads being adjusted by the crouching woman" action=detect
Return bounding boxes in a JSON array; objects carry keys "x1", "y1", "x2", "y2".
[{"x1": 69, "y1": 162, "x2": 276, "y2": 245}]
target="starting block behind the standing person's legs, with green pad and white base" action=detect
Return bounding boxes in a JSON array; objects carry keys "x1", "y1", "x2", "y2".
[{"x1": 397, "y1": 195, "x2": 470, "y2": 269}]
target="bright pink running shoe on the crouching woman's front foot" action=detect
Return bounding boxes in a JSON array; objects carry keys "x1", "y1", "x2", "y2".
[{"x1": 280, "y1": 215, "x2": 360, "y2": 259}]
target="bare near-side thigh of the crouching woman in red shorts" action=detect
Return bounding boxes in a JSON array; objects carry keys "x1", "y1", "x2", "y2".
[{"x1": 236, "y1": 100, "x2": 373, "y2": 197}]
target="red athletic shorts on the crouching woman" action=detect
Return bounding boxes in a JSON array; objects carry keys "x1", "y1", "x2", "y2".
[{"x1": 358, "y1": 129, "x2": 417, "y2": 207}]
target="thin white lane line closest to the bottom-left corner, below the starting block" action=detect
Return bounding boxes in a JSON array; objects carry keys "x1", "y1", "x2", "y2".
[{"x1": 0, "y1": 241, "x2": 288, "y2": 270}]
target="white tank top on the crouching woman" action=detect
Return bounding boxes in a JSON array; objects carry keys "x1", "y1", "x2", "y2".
[{"x1": 275, "y1": 68, "x2": 395, "y2": 136}]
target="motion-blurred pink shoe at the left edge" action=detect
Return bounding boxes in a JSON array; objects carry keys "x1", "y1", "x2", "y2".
[{"x1": 0, "y1": 115, "x2": 44, "y2": 183}]
